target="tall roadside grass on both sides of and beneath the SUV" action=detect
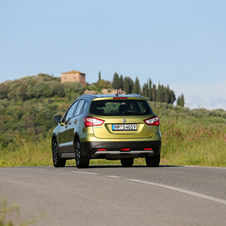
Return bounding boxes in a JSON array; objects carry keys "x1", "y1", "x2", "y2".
[{"x1": 0, "y1": 109, "x2": 226, "y2": 167}]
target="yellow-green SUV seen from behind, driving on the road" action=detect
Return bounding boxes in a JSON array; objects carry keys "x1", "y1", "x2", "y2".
[{"x1": 52, "y1": 94, "x2": 161, "y2": 168}]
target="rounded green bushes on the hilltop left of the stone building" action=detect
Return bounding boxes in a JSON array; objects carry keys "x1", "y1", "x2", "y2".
[{"x1": 0, "y1": 73, "x2": 83, "y2": 101}]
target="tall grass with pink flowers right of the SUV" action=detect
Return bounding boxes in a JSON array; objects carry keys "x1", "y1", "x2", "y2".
[{"x1": 161, "y1": 115, "x2": 226, "y2": 166}]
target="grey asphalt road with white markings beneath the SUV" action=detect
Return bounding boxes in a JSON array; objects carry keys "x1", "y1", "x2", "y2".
[{"x1": 0, "y1": 166, "x2": 226, "y2": 226}]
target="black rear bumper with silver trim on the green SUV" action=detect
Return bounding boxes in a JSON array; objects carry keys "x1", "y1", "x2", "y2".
[{"x1": 81, "y1": 141, "x2": 161, "y2": 159}]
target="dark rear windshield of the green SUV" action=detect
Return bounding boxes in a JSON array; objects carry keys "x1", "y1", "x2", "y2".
[{"x1": 90, "y1": 99, "x2": 153, "y2": 116}]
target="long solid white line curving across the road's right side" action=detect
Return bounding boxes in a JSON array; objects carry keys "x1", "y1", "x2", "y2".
[{"x1": 127, "y1": 179, "x2": 226, "y2": 205}]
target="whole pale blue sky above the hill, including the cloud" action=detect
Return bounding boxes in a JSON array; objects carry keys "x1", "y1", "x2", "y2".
[{"x1": 0, "y1": 0, "x2": 226, "y2": 110}]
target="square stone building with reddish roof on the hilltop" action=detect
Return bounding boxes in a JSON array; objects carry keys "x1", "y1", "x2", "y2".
[{"x1": 61, "y1": 70, "x2": 86, "y2": 86}]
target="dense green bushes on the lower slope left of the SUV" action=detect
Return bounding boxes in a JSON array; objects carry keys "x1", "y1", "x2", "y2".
[{"x1": 0, "y1": 98, "x2": 70, "y2": 147}]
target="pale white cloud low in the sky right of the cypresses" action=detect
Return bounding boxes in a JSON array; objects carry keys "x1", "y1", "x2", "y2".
[{"x1": 170, "y1": 80, "x2": 226, "y2": 110}]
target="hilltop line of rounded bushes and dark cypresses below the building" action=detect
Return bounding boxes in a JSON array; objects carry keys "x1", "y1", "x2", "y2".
[{"x1": 0, "y1": 72, "x2": 185, "y2": 107}]
